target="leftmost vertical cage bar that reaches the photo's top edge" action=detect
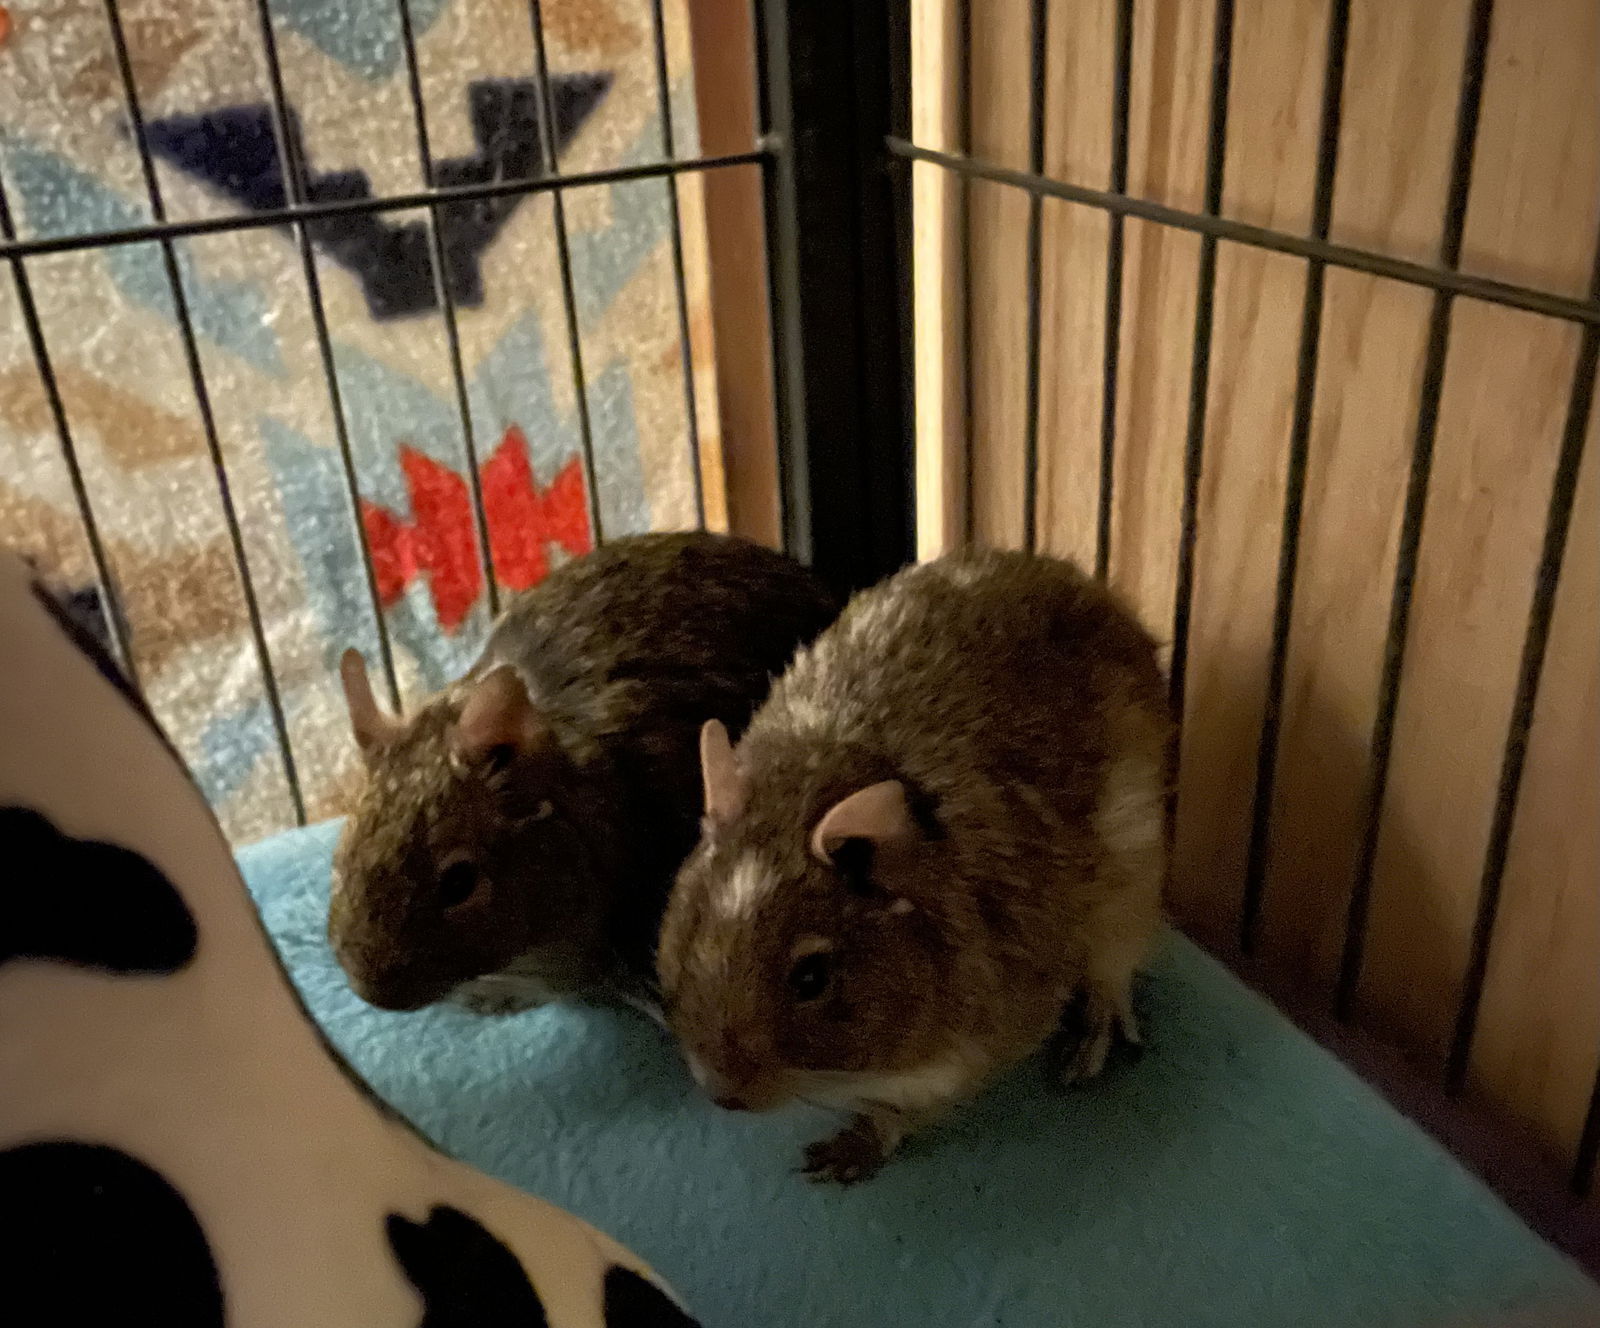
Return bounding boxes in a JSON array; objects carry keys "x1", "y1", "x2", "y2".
[{"x1": 104, "y1": 0, "x2": 306, "y2": 826}]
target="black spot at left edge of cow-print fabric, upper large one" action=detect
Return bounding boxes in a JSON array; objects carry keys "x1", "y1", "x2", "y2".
[{"x1": 0, "y1": 806, "x2": 197, "y2": 973}]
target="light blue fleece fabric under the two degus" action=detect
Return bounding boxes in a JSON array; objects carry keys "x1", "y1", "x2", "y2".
[{"x1": 240, "y1": 826, "x2": 1600, "y2": 1328}]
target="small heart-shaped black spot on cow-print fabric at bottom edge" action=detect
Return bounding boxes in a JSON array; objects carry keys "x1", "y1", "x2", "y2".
[{"x1": 387, "y1": 1205, "x2": 549, "y2": 1328}]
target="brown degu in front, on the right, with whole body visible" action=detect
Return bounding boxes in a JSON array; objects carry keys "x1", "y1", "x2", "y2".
[{"x1": 659, "y1": 552, "x2": 1171, "y2": 1181}]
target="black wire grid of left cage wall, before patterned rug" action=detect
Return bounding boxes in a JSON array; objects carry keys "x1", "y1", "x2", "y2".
[{"x1": 0, "y1": 0, "x2": 781, "y2": 844}]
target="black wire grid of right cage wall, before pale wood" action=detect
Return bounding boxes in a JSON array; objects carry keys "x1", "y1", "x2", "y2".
[{"x1": 886, "y1": 0, "x2": 1600, "y2": 1194}]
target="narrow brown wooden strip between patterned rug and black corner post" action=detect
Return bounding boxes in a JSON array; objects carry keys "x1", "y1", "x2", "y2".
[{"x1": 680, "y1": 0, "x2": 781, "y2": 547}]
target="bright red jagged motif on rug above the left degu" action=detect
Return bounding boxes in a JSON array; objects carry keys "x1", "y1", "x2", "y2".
[{"x1": 362, "y1": 424, "x2": 594, "y2": 632}]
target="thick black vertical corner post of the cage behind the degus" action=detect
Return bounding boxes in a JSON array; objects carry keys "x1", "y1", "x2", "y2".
[{"x1": 755, "y1": 0, "x2": 915, "y2": 589}]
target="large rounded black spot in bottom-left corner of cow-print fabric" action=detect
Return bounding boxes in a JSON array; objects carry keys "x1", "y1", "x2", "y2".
[{"x1": 0, "y1": 1141, "x2": 224, "y2": 1328}]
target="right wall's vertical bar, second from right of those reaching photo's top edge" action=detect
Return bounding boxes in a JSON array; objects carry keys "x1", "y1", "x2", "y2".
[{"x1": 1238, "y1": 0, "x2": 1350, "y2": 955}]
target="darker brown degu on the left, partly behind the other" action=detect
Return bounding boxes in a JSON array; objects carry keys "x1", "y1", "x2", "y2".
[{"x1": 328, "y1": 534, "x2": 838, "y2": 1013}]
